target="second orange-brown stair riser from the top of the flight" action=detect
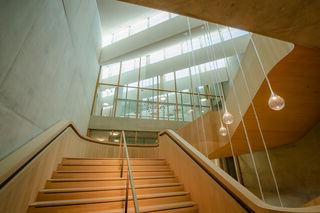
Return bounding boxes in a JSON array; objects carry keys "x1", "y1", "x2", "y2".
[{"x1": 57, "y1": 164, "x2": 170, "y2": 171}]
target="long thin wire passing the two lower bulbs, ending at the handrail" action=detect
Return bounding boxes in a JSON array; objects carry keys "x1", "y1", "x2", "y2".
[{"x1": 203, "y1": 22, "x2": 240, "y2": 182}]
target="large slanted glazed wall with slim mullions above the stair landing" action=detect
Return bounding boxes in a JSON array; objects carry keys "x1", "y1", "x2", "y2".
[{"x1": 93, "y1": 26, "x2": 248, "y2": 121}]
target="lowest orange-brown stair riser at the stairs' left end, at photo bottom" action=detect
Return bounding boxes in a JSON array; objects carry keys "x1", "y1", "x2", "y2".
[{"x1": 29, "y1": 195, "x2": 190, "y2": 213}]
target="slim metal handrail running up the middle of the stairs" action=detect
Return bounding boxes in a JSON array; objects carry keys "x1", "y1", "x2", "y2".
[{"x1": 119, "y1": 131, "x2": 140, "y2": 213}]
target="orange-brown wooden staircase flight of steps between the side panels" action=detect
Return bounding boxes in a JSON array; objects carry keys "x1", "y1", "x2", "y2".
[{"x1": 28, "y1": 158, "x2": 198, "y2": 213}]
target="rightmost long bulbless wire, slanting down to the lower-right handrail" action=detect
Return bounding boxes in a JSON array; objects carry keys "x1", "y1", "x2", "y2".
[{"x1": 228, "y1": 27, "x2": 283, "y2": 207}]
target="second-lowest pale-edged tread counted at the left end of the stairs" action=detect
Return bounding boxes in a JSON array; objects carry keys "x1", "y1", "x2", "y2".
[{"x1": 40, "y1": 183, "x2": 182, "y2": 193}]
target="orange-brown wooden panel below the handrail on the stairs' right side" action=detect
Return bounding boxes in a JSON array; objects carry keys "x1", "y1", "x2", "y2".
[{"x1": 159, "y1": 135, "x2": 246, "y2": 213}]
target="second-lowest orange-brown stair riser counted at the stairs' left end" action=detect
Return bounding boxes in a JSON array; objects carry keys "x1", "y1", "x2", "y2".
[{"x1": 37, "y1": 185, "x2": 183, "y2": 201}]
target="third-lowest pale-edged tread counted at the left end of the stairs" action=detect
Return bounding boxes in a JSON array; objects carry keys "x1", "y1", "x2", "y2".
[{"x1": 48, "y1": 175, "x2": 176, "y2": 182}]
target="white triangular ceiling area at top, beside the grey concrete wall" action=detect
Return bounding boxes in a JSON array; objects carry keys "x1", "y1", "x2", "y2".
[{"x1": 97, "y1": 0, "x2": 159, "y2": 35}]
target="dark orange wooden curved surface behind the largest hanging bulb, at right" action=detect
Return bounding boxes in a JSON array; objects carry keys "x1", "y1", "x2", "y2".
[{"x1": 210, "y1": 45, "x2": 320, "y2": 158}]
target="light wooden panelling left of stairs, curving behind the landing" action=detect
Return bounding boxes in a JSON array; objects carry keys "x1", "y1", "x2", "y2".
[{"x1": 0, "y1": 127, "x2": 158, "y2": 213}]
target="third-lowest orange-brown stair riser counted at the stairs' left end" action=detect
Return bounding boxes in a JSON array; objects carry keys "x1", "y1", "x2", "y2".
[{"x1": 45, "y1": 178, "x2": 178, "y2": 189}]
